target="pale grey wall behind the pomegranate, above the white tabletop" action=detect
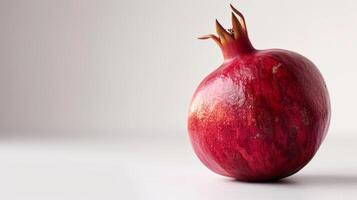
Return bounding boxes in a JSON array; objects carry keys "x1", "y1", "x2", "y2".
[{"x1": 0, "y1": 0, "x2": 357, "y2": 137}]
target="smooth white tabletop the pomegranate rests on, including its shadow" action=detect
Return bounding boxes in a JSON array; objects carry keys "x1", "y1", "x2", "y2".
[{"x1": 0, "y1": 133, "x2": 357, "y2": 200}]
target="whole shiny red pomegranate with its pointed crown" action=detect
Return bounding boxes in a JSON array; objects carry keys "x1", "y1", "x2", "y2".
[{"x1": 188, "y1": 5, "x2": 331, "y2": 182}]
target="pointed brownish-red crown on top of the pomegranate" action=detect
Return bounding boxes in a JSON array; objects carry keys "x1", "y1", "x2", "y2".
[{"x1": 198, "y1": 4, "x2": 255, "y2": 59}]
